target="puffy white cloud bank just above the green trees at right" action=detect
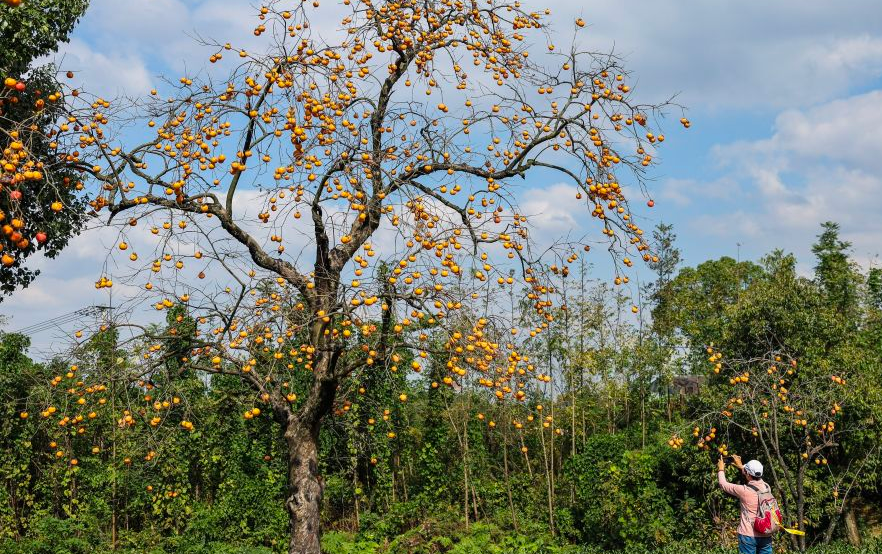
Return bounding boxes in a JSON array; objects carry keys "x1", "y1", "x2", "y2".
[{"x1": 693, "y1": 91, "x2": 882, "y2": 260}]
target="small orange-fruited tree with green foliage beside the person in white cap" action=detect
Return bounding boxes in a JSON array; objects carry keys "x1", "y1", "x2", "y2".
[{"x1": 668, "y1": 253, "x2": 879, "y2": 549}]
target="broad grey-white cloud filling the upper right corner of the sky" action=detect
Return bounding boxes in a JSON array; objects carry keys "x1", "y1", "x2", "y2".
[{"x1": 553, "y1": 0, "x2": 882, "y2": 111}]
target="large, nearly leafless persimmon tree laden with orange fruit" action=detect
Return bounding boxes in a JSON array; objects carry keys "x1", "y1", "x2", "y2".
[{"x1": 27, "y1": 0, "x2": 689, "y2": 553}]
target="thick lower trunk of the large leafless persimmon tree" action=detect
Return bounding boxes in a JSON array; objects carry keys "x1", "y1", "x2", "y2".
[{"x1": 285, "y1": 418, "x2": 324, "y2": 554}]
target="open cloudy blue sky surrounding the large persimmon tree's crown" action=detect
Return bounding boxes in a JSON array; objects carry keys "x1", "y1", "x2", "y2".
[{"x1": 0, "y1": 0, "x2": 882, "y2": 345}]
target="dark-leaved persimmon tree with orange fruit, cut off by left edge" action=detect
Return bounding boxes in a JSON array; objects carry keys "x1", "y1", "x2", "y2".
[{"x1": 0, "y1": 0, "x2": 88, "y2": 299}]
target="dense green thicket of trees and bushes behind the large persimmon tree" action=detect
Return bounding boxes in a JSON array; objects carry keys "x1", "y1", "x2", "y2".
[{"x1": 0, "y1": 222, "x2": 882, "y2": 554}]
